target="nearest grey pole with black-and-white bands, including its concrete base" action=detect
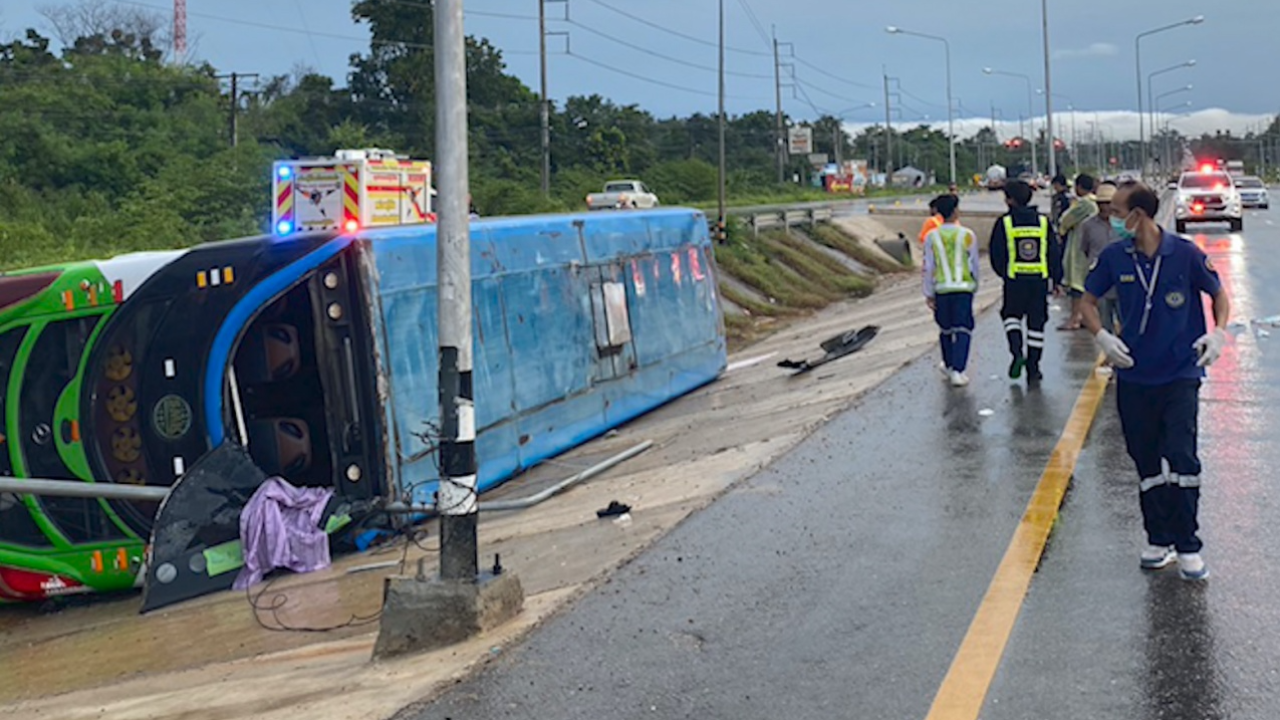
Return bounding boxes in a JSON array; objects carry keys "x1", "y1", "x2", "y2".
[{"x1": 374, "y1": 0, "x2": 524, "y2": 657}]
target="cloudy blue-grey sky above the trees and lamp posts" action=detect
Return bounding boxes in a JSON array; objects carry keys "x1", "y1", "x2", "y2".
[{"x1": 0, "y1": 0, "x2": 1280, "y2": 136}]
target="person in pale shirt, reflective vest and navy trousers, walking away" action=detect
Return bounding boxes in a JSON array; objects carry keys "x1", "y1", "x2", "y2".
[{"x1": 924, "y1": 195, "x2": 978, "y2": 387}]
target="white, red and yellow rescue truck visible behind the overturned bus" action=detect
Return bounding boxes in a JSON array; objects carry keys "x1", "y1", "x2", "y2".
[{"x1": 271, "y1": 149, "x2": 435, "y2": 236}]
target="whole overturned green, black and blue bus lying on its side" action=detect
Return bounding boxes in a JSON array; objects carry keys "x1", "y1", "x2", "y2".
[{"x1": 0, "y1": 209, "x2": 726, "y2": 602}]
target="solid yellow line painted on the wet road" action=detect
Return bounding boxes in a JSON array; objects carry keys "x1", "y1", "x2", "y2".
[{"x1": 925, "y1": 368, "x2": 1108, "y2": 720}]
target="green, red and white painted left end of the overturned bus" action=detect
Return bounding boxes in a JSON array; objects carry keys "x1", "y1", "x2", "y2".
[{"x1": 0, "y1": 252, "x2": 179, "y2": 602}]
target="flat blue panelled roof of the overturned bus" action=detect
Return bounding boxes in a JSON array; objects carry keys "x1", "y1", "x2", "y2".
[{"x1": 357, "y1": 209, "x2": 726, "y2": 502}]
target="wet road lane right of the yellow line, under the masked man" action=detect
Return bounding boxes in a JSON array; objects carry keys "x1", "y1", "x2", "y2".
[{"x1": 983, "y1": 211, "x2": 1280, "y2": 720}]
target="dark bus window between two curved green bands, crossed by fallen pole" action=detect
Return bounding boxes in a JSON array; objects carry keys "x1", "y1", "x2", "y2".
[{"x1": 14, "y1": 315, "x2": 125, "y2": 543}]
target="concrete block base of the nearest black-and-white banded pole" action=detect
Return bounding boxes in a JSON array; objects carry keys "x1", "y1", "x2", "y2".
[{"x1": 374, "y1": 573, "x2": 525, "y2": 660}]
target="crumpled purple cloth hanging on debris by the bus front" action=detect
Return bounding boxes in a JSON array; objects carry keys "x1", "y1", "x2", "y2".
[{"x1": 234, "y1": 478, "x2": 333, "y2": 591}]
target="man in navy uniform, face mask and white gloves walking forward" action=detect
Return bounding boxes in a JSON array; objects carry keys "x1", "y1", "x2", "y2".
[{"x1": 1083, "y1": 183, "x2": 1230, "y2": 580}]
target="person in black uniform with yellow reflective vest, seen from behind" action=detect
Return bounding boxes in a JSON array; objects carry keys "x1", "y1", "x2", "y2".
[{"x1": 988, "y1": 181, "x2": 1062, "y2": 383}]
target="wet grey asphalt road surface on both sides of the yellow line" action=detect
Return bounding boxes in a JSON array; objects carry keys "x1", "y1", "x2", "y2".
[{"x1": 402, "y1": 204, "x2": 1280, "y2": 720}]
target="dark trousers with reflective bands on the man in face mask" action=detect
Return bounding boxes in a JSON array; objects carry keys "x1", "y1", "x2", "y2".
[{"x1": 1116, "y1": 380, "x2": 1202, "y2": 552}]
